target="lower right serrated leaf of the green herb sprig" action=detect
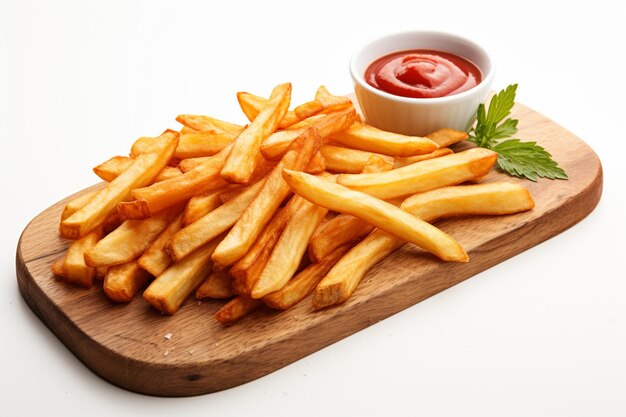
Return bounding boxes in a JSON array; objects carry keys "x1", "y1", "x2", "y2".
[{"x1": 493, "y1": 139, "x2": 567, "y2": 181}]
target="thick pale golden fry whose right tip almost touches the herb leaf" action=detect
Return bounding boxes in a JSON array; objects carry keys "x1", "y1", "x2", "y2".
[{"x1": 337, "y1": 148, "x2": 498, "y2": 200}]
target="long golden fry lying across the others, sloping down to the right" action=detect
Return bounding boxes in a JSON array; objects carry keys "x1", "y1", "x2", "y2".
[{"x1": 283, "y1": 169, "x2": 468, "y2": 262}]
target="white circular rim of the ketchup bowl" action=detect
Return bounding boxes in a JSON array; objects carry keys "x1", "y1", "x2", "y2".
[{"x1": 349, "y1": 30, "x2": 495, "y2": 104}]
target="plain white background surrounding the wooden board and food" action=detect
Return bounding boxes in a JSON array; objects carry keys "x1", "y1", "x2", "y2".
[{"x1": 0, "y1": 0, "x2": 626, "y2": 416}]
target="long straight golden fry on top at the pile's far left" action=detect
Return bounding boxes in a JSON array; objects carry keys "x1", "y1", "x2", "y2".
[{"x1": 61, "y1": 130, "x2": 182, "y2": 239}]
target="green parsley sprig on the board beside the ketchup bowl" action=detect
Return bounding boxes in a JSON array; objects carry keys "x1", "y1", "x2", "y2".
[{"x1": 468, "y1": 84, "x2": 567, "y2": 181}]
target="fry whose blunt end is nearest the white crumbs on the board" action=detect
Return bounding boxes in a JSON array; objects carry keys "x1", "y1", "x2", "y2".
[{"x1": 143, "y1": 237, "x2": 221, "y2": 314}]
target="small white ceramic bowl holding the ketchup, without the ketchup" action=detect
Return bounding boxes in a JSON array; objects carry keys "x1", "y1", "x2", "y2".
[{"x1": 350, "y1": 31, "x2": 494, "y2": 136}]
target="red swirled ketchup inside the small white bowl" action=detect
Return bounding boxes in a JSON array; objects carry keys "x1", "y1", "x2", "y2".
[{"x1": 365, "y1": 49, "x2": 482, "y2": 98}]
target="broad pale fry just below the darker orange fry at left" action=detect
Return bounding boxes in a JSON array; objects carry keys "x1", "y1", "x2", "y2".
[{"x1": 85, "y1": 207, "x2": 182, "y2": 266}]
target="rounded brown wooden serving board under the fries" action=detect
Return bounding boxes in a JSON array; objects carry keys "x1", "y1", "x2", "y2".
[{"x1": 16, "y1": 105, "x2": 602, "y2": 396}]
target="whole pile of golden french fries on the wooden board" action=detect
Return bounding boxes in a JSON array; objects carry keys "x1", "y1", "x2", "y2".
[{"x1": 51, "y1": 83, "x2": 534, "y2": 324}]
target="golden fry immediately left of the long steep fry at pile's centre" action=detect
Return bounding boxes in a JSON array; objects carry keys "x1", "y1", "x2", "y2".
[{"x1": 166, "y1": 181, "x2": 265, "y2": 261}]
